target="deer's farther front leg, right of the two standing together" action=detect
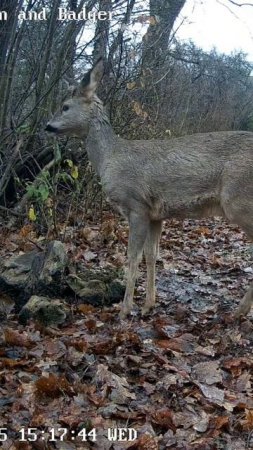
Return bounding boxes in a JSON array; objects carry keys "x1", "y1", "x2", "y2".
[{"x1": 142, "y1": 221, "x2": 162, "y2": 314}]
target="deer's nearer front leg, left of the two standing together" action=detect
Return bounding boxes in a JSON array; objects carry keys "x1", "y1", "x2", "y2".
[{"x1": 120, "y1": 213, "x2": 149, "y2": 319}]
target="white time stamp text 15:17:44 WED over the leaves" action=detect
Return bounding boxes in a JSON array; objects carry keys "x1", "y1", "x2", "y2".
[{"x1": 0, "y1": 427, "x2": 137, "y2": 444}]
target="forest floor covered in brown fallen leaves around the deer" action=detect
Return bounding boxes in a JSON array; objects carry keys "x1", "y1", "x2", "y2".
[{"x1": 0, "y1": 214, "x2": 253, "y2": 450}]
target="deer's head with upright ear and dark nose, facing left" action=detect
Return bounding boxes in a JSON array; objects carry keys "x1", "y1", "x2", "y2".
[{"x1": 46, "y1": 59, "x2": 104, "y2": 137}]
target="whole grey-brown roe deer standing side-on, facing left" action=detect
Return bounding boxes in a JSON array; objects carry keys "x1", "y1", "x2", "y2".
[{"x1": 46, "y1": 59, "x2": 253, "y2": 318}]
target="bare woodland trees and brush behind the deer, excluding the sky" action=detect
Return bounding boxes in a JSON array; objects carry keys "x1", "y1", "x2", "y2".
[{"x1": 0, "y1": 0, "x2": 253, "y2": 225}]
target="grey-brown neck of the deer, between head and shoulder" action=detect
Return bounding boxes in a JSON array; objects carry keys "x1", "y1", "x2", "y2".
[{"x1": 87, "y1": 98, "x2": 118, "y2": 177}]
